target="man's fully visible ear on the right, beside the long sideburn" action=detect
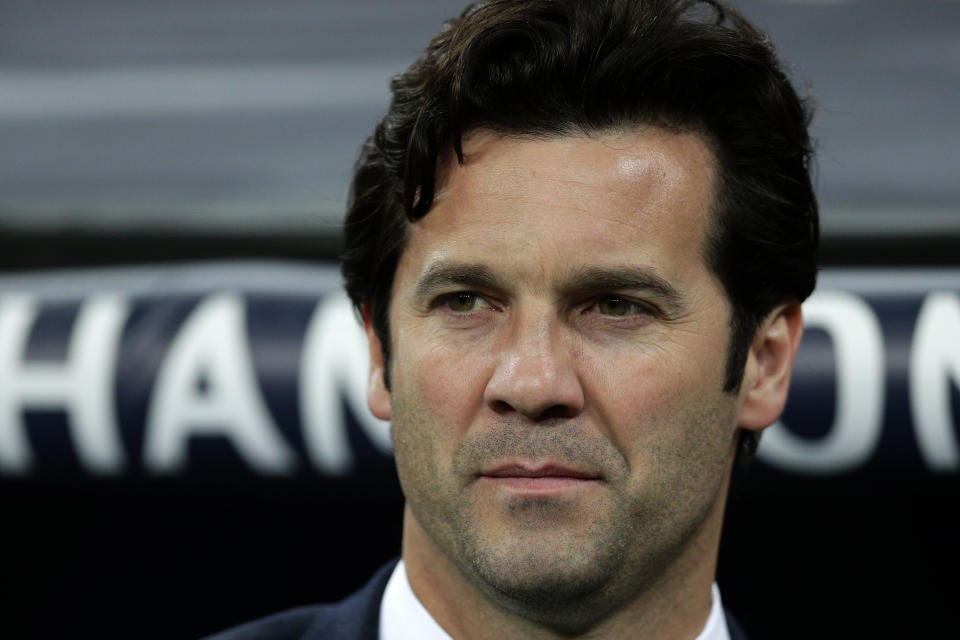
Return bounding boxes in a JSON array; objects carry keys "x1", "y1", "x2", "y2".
[{"x1": 739, "y1": 302, "x2": 803, "y2": 431}]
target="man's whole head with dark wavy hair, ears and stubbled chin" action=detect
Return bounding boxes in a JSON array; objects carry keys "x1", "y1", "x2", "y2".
[{"x1": 344, "y1": 0, "x2": 817, "y2": 630}]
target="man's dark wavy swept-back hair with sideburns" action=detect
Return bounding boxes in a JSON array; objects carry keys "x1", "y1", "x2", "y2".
[{"x1": 343, "y1": 0, "x2": 819, "y2": 460}]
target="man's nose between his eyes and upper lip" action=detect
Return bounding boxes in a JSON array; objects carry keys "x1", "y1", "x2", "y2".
[{"x1": 484, "y1": 312, "x2": 584, "y2": 421}]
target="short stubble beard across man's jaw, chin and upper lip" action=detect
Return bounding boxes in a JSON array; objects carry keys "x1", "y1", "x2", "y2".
[{"x1": 394, "y1": 394, "x2": 736, "y2": 633}]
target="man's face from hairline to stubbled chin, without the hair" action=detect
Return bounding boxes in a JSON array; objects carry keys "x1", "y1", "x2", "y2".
[{"x1": 371, "y1": 128, "x2": 742, "y2": 615}]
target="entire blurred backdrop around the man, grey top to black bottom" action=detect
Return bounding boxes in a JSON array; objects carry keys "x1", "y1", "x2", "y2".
[{"x1": 0, "y1": 0, "x2": 960, "y2": 639}]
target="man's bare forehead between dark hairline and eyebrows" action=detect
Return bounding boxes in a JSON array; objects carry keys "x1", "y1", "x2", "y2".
[{"x1": 401, "y1": 127, "x2": 715, "y2": 288}]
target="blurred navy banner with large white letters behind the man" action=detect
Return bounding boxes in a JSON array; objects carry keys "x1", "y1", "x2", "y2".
[{"x1": 0, "y1": 261, "x2": 960, "y2": 477}]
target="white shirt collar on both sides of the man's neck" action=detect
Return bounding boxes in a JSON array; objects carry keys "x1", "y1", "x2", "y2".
[{"x1": 380, "y1": 560, "x2": 730, "y2": 640}]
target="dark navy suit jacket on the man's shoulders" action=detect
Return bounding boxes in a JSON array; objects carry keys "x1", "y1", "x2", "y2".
[{"x1": 206, "y1": 560, "x2": 747, "y2": 640}]
